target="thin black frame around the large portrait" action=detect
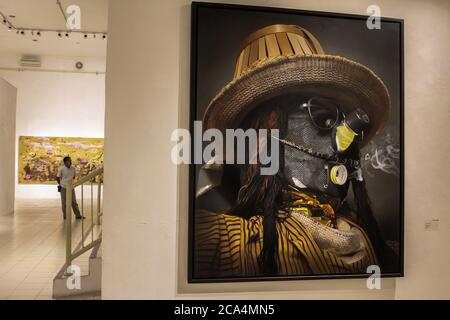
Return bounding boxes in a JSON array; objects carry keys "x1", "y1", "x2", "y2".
[{"x1": 187, "y1": 2, "x2": 405, "y2": 283}]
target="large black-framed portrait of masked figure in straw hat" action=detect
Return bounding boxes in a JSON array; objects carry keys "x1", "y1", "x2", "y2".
[{"x1": 188, "y1": 2, "x2": 404, "y2": 282}]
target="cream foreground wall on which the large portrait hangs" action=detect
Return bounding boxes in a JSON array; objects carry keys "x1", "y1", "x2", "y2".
[{"x1": 102, "y1": 0, "x2": 450, "y2": 299}]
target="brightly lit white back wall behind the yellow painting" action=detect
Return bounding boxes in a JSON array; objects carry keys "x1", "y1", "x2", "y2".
[{"x1": 0, "y1": 56, "x2": 105, "y2": 199}]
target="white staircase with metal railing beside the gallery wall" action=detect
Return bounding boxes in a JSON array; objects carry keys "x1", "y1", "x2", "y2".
[{"x1": 53, "y1": 168, "x2": 103, "y2": 299}]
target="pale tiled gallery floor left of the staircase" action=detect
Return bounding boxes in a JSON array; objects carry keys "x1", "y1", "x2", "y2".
[{"x1": 0, "y1": 200, "x2": 93, "y2": 300}]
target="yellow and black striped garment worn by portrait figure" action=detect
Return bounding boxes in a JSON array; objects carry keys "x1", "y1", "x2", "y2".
[{"x1": 194, "y1": 210, "x2": 377, "y2": 278}]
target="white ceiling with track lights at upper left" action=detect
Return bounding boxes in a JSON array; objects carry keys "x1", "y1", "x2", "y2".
[{"x1": 0, "y1": 0, "x2": 108, "y2": 57}]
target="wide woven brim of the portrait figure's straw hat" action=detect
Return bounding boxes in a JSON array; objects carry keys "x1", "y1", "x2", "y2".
[{"x1": 203, "y1": 55, "x2": 390, "y2": 145}]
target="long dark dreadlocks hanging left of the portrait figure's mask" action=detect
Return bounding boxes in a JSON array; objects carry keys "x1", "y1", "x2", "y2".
[{"x1": 232, "y1": 107, "x2": 287, "y2": 275}]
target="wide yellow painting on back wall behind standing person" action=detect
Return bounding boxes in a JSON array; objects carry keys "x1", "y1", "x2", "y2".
[{"x1": 18, "y1": 136, "x2": 104, "y2": 184}]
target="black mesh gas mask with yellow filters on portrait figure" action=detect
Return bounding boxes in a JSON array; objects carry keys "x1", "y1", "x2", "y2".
[{"x1": 281, "y1": 98, "x2": 369, "y2": 199}]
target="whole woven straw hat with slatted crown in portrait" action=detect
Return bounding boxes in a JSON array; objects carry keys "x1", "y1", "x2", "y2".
[{"x1": 203, "y1": 24, "x2": 390, "y2": 145}]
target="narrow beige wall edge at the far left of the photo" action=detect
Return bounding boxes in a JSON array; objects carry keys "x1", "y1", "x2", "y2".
[{"x1": 0, "y1": 77, "x2": 17, "y2": 215}]
